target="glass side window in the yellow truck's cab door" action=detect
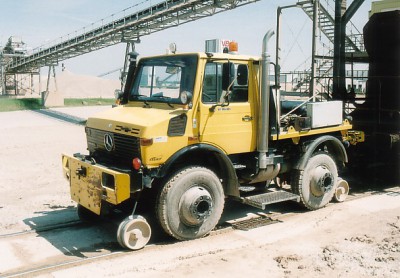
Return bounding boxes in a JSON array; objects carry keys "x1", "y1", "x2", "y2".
[{"x1": 201, "y1": 62, "x2": 248, "y2": 103}]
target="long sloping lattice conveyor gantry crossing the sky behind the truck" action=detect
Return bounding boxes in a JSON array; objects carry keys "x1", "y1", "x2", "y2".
[{"x1": 5, "y1": 0, "x2": 259, "y2": 73}]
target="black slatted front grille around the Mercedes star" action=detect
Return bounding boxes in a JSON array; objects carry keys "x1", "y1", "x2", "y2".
[{"x1": 86, "y1": 128, "x2": 141, "y2": 165}]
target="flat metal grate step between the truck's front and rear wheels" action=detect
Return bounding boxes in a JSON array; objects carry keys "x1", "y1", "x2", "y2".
[{"x1": 240, "y1": 190, "x2": 300, "y2": 209}]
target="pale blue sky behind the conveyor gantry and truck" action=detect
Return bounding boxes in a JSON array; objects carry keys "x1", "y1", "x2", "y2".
[{"x1": 0, "y1": 0, "x2": 371, "y2": 78}]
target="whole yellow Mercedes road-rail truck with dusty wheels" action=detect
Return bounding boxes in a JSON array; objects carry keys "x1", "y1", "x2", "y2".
[{"x1": 62, "y1": 31, "x2": 362, "y2": 250}]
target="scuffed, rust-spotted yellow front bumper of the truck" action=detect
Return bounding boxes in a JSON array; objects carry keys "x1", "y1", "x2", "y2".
[{"x1": 62, "y1": 154, "x2": 130, "y2": 215}]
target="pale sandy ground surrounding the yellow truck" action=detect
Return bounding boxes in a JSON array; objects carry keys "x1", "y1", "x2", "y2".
[{"x1": 0, "y1": 107, "x2": 400, "y2": 277}]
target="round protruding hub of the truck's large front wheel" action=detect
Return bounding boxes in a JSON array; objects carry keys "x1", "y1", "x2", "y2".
[{"x1": 179, "y1": 186, "x2": 213, "y2": 225}]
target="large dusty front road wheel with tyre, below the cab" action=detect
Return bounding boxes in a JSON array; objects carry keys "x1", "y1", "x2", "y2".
[{"x1": 156, "y1": 167, "x2": 225, "y2": 240}]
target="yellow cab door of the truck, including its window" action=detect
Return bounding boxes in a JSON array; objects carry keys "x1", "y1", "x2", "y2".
[{"x1": 199, "y1": 60, "x2": 256, "y2": 154}]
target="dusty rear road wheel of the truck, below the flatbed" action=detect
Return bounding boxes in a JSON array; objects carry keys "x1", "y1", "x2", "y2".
[{"x1": 292, "y1": 153, "x2": 338, "y2": 210}]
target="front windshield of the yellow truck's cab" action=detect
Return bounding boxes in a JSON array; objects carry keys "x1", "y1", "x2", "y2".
[{"x1": 129, "y1": 55, "x2": 197, "y2": 104}]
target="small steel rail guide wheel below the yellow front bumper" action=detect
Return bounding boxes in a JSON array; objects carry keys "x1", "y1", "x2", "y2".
[{"x1": 117, "y1": 215, "x2": 151, "y2": 250}]
